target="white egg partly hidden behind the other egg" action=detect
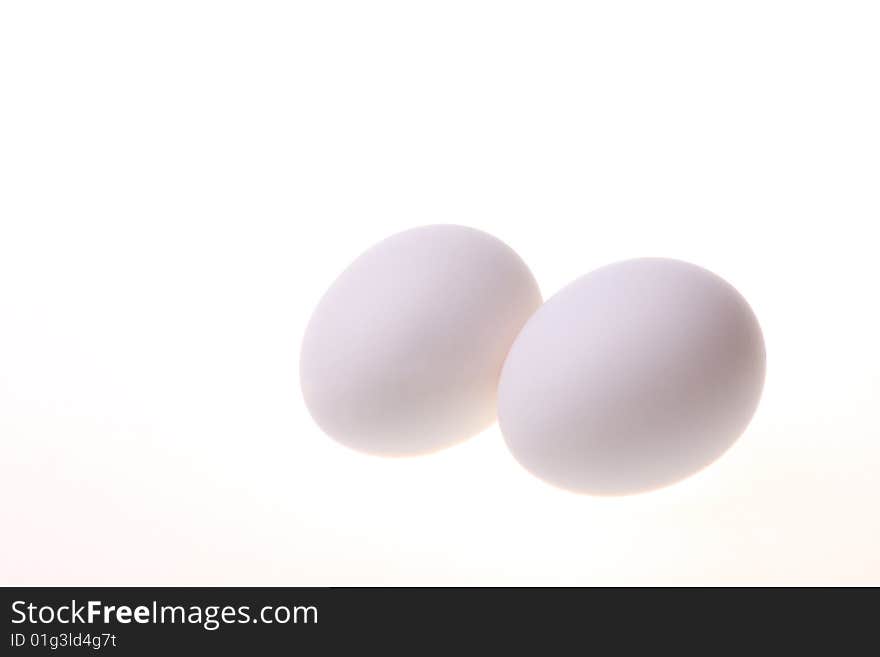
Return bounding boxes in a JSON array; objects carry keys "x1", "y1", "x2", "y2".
[{"x1": 300, "y1": 225, "x2": 541, "y2": 456}]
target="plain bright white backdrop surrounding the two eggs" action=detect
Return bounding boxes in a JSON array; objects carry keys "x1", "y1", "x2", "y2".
[{"x1": 0, "y1": 0, "x2": 880, "y2": 585}]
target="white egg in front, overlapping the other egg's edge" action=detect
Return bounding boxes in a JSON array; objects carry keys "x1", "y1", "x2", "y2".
[{"x1": 498, "y1": 258, "x2": 765, "y2": 495}]
